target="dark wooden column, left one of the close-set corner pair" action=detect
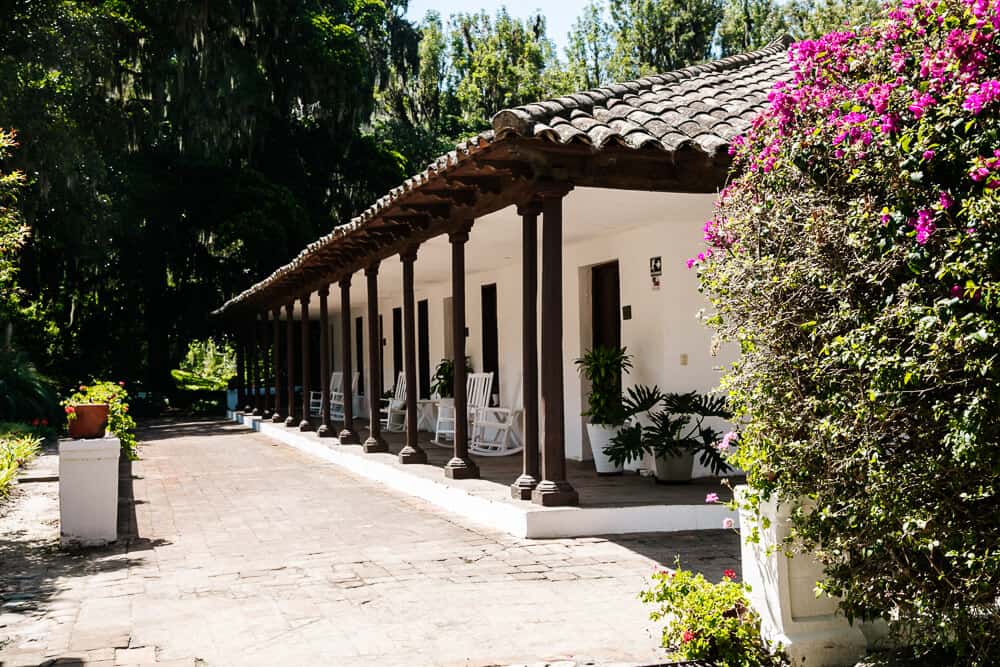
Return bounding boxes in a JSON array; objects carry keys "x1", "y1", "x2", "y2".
[{"x1": 510, "y1": 202, "x2": 541, "y2": 500}]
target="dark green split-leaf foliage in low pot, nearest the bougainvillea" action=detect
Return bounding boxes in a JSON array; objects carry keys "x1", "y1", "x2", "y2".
[{"x1": 604, "y1": 385, "x2": 732, "y2": 475}]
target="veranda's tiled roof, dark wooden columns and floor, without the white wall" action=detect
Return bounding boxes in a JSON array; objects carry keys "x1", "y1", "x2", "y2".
[{"x1": 217, "y1": 41, "x2": 787, "y2": 520}]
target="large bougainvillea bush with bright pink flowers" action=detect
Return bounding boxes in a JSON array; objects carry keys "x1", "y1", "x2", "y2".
[{"x1": 691, "y1": 0, "x2": 1000, "y2": 664}]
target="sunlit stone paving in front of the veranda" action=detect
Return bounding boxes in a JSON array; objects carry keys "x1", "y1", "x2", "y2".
[{"x1": 0, "y1": 422, "x2": 739, "y2": 667}]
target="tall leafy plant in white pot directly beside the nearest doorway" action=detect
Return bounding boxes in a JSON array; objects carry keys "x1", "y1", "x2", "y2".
[{"x1": 574, "y1": 346, "x2": 658, "y2": 475}]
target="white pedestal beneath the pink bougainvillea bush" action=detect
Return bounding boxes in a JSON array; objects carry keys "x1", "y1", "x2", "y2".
[{"x1": 736, "y1": 486, "x2": 867, "y2": 667}]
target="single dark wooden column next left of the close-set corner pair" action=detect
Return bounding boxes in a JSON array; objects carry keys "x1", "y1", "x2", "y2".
[{"x1": 444, "y1": 220, "x2": 479, "y2": 479}]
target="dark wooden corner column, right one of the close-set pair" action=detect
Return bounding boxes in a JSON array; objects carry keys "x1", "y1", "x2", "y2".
[{"x1": 531, "y1": 186, "x2": 580, "y2": 506}]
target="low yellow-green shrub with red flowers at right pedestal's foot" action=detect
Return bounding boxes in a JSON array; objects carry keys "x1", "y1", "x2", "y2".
[{"x1": 639, "y1": 561, "x2": 789, "y2": 667}]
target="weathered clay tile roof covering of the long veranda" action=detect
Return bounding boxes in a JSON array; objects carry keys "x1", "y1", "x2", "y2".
[{"x1": 215, "y1": 36, "x2": 792, "y2": 314}]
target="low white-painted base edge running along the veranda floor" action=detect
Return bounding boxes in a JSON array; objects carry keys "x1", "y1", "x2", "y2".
[{"x1": 230, "y1": 412, "x2": 736, "y2": 538}]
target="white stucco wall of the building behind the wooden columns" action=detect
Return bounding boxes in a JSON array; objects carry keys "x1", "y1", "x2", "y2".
[{"x1": 312, "y1": 190, "x2": 733, "y2": 475}]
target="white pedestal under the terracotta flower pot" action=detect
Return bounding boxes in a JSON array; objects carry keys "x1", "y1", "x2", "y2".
[{"x1": 59, "y1": 437, "x2": 121, "y2": 547}]
